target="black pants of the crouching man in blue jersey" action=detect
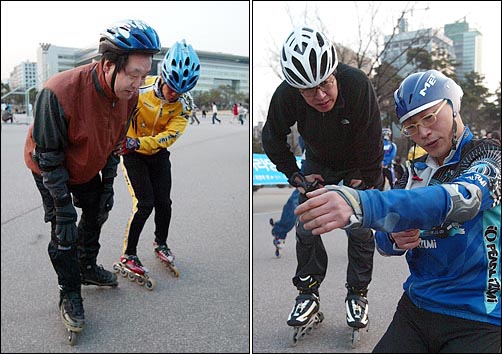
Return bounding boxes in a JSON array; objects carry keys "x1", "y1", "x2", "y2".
[{"x1": 373, "y1": 294, "x2": 500, "y2": 353}]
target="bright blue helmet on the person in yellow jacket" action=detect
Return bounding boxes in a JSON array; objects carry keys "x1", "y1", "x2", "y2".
[{"x1": 162, "y1": 39, "x2": 200, "y2": 93}]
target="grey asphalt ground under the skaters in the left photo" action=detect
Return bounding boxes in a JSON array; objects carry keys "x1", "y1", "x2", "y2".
[{"x1": 1, "y1": 115, "x2": 250, "y2": 353}]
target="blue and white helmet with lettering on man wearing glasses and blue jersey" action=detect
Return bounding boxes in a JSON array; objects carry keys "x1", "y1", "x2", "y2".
[{"x1": 394, "y1": 70, "x2": 464, "y2": 124}]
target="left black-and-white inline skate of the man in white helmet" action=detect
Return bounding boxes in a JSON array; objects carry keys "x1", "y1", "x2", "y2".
[{"x1": 287, "y1": 293, "x2": 324, "y2": 346}]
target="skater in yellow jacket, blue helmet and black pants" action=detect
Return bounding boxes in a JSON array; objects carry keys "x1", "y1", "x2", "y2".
[{"x1": 114, "y1": 40, "x2": 200, "y2": 289}]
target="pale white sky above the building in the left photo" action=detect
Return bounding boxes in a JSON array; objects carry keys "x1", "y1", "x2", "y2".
[{"x1": 1, "y1": 1, "x2": 250, "y2": 79}]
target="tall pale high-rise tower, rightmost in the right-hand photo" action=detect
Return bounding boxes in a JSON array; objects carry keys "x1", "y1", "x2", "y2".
[{"x1": 444, "y1": 18, "x2": 483, "y2": 79}]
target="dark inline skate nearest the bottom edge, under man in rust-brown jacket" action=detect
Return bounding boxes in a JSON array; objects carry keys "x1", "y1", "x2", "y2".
[{"x1": 59, "y1": 291, "x2": 85, "y2": 346}]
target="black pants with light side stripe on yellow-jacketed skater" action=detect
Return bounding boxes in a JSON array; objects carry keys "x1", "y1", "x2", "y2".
[{"x1": 123, "y1": 149, "x2": 172, "y2": 255}]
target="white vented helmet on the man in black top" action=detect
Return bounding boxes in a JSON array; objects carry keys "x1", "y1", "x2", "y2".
[{"x1": 281, "y1": 27, "x2": 338, "y2": 89}]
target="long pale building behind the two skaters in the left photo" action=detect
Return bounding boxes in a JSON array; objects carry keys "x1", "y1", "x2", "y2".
[{"x1": 37, "y1": 44, "x2": 249, "y2": 94}]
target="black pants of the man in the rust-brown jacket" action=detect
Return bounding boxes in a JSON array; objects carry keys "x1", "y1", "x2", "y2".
[{"x1": 33, "y1": 174, "x2": 108, "y2": 291}]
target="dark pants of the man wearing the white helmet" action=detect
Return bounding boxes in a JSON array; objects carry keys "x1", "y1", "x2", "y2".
[{"x1": 293, "y1": 161, "x2": 375, "y2": 291}]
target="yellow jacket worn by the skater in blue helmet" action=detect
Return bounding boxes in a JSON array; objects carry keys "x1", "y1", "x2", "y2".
[{"x1": 127, "y1": 76, "x2": 193, "y2": 155}]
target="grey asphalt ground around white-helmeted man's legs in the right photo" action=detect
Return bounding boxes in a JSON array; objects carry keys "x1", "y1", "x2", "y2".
[{"x1": 252, "y1": 187, "x2": 408, "y2": 353}]
